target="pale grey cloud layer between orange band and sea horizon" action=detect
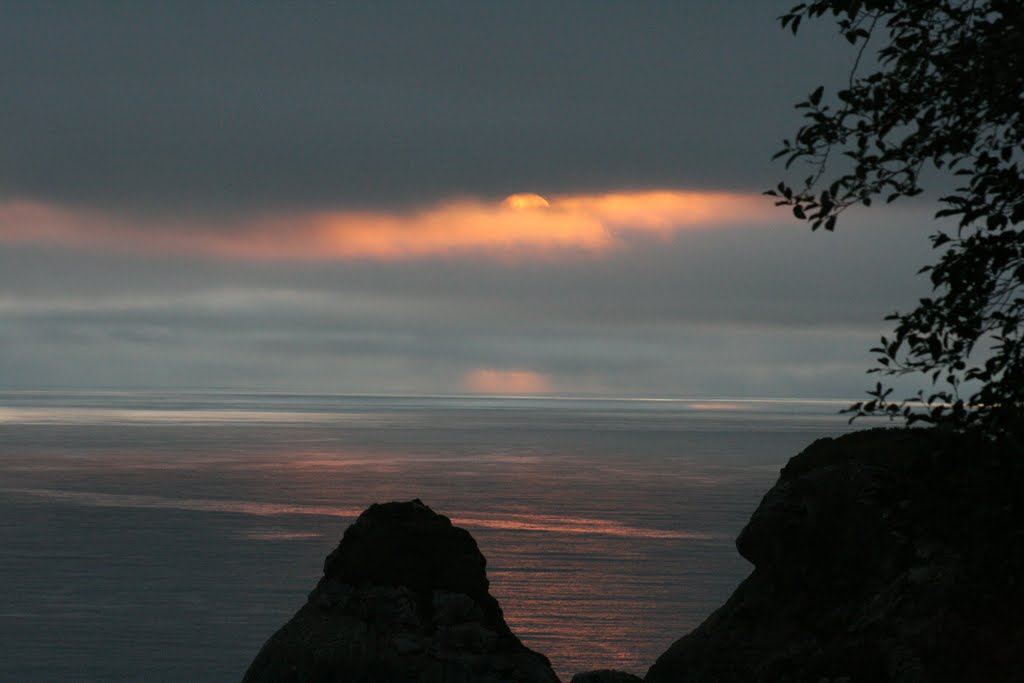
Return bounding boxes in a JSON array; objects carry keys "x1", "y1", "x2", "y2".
[{"x1": 0, "y1": 200, "x2": 928, "y2": 396}]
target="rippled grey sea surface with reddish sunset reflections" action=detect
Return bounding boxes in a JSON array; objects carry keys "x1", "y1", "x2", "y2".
[{"x1": 0, "y1": 391, "x2": 864, "y2": 681}]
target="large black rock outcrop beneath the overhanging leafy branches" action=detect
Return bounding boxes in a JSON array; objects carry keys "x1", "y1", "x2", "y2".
[{"x1": 645, "y1": 429, "x2": 1024, "y2": 683}]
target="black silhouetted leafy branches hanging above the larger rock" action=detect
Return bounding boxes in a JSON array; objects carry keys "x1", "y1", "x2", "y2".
[{"x1": 767, "y1": 0, "x2": 1024, "y2": 437}]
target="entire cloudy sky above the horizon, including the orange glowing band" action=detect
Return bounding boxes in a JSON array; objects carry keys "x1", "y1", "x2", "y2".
[{"x1": 0, "y1": 0, "x2": 933, "y2": 398}]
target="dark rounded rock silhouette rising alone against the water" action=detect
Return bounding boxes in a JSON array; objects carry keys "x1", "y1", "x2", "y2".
[{"x1": 243, "y1": 500, "x2": 558, "y2": 683}]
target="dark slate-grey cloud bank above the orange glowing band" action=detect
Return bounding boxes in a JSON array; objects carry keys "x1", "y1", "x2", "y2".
[{"x1": 0, "y1": 0, "x2": 849, "y2": 212}]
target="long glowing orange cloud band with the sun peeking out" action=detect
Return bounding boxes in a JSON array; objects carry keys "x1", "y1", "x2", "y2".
[{"x1": 0, "y1": 190, "x2": 777, "y2": 261}]
